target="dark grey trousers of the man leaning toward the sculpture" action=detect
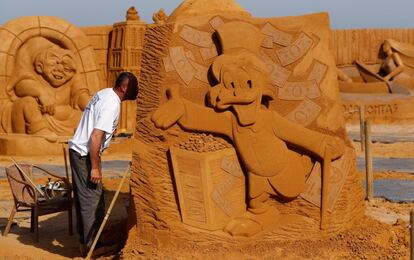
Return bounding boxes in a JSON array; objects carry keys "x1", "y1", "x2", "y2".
[{"x1": 71, "y1": 151, "x2": 105, "y2": 249}]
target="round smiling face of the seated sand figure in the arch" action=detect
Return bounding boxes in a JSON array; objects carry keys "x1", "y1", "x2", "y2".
[{"x1": 34, "y1": 47, "x2": 76, "y2": 88}]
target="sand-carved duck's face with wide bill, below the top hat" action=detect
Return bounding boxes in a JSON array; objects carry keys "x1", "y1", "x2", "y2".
[{"x1": 209, "y1": 52, "x2": 272, "y2": 126}]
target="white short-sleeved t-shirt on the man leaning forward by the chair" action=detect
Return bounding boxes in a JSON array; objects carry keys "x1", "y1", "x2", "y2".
[{"x1": 69, "y1": 88, "x2": 121, "y2": 156}]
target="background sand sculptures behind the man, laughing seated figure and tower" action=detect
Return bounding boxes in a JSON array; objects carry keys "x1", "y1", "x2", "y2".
[{"x1": 0, "y1": 7, "x2": 147, "y2": 155}]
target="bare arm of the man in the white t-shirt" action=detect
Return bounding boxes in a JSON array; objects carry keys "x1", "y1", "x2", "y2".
[{"x1": 89, "y1": 129, "x2": 105, "y2": 183}]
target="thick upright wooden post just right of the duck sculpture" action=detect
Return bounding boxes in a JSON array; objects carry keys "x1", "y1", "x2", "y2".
[{"x1": 365, "y1": 120, "x2": 374, "y2": 201}]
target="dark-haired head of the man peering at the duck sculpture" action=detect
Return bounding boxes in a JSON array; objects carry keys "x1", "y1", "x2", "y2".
[{"x1": 114, "y1": 72, "x2": 138, "y2": 101}]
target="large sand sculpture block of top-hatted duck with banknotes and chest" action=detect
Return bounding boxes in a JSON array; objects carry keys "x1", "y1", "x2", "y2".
[{"x1": 125, "y1": 0, "x2": 363, "y2": 257}]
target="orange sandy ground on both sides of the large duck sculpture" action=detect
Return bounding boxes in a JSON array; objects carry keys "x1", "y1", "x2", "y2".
[{"x1": 0, "y1": 135, "x2": 414, "y2": 259}]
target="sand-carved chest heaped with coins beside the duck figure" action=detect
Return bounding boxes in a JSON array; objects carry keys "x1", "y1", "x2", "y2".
[{"x1": 170, "y1": 134, "x2": 246, "y2": 230}]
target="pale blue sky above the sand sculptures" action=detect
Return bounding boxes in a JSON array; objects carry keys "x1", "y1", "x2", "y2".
[{"x1": 0, "y1": 0, "x2": 414, "y2": 29}]
